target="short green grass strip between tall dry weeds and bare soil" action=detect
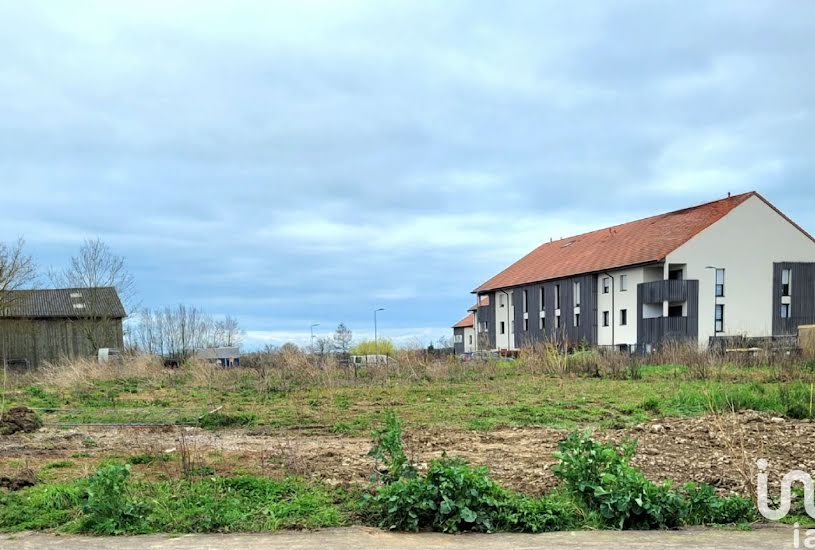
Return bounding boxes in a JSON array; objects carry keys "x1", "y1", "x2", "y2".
[{"x1": 7, "y1": 363, "x2": 813, "y2": 435}]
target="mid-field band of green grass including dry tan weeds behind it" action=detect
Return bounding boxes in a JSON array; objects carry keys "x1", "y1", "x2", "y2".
[{"x1": 4, "y1": 346, "x2": 815, "y2": 435}]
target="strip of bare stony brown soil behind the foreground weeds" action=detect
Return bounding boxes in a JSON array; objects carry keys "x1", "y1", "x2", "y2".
[{"x1": 0, "y1": 411, "x2": 815, "y2": 494}]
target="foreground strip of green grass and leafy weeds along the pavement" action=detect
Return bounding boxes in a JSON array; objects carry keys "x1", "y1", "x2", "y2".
[{"x1": 0, "y1": 413, "x2": 754, "y2": 535}]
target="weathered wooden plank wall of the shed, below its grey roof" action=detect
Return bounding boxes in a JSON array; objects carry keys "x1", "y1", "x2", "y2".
[{"x1": 0, "y1": 319, "x2": 124, "y2": 367}]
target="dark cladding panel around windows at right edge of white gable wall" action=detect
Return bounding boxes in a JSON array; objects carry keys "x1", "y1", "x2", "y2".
[{"x1": 773, "y1": 262, "x2": 815, "y2": 336}]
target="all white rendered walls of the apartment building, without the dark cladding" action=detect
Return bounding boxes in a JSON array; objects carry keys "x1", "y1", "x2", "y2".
[{"x1": 472, "y1": 194, "x2": 815, "y2": 350}]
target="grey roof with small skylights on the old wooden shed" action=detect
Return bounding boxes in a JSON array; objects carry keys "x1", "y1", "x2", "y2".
[{"x1": 0, "y1": 287, "x2": 127, "y2": 319}]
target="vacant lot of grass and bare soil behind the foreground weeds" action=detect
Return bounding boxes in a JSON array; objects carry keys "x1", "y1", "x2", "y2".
[{"x1": 0, "y1": 359, "x2": 815, "y2": 528}]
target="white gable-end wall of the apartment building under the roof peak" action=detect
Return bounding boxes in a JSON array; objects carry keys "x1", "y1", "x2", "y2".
[{"x1": 666, "y1": 196, "x2": 815, "y2": 347}]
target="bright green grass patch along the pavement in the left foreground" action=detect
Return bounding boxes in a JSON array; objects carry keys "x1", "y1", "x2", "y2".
[{"x1": 0, "y1": 474, "x2": 356, "y2": 534}]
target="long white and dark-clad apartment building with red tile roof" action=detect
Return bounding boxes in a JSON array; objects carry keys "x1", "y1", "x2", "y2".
[{"x1": 462, "y1": 192, "x2": 815, "y2": 350}]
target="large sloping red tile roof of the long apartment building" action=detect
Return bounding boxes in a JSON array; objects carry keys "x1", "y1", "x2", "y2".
[{"x1": 473, "y1": 191, "x2": 756, "y2": 292}]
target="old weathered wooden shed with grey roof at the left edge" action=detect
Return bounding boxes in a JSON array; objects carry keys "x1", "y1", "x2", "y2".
[{"x1": 0, "y1": 287, "x2": 126, "y2": 367}]
